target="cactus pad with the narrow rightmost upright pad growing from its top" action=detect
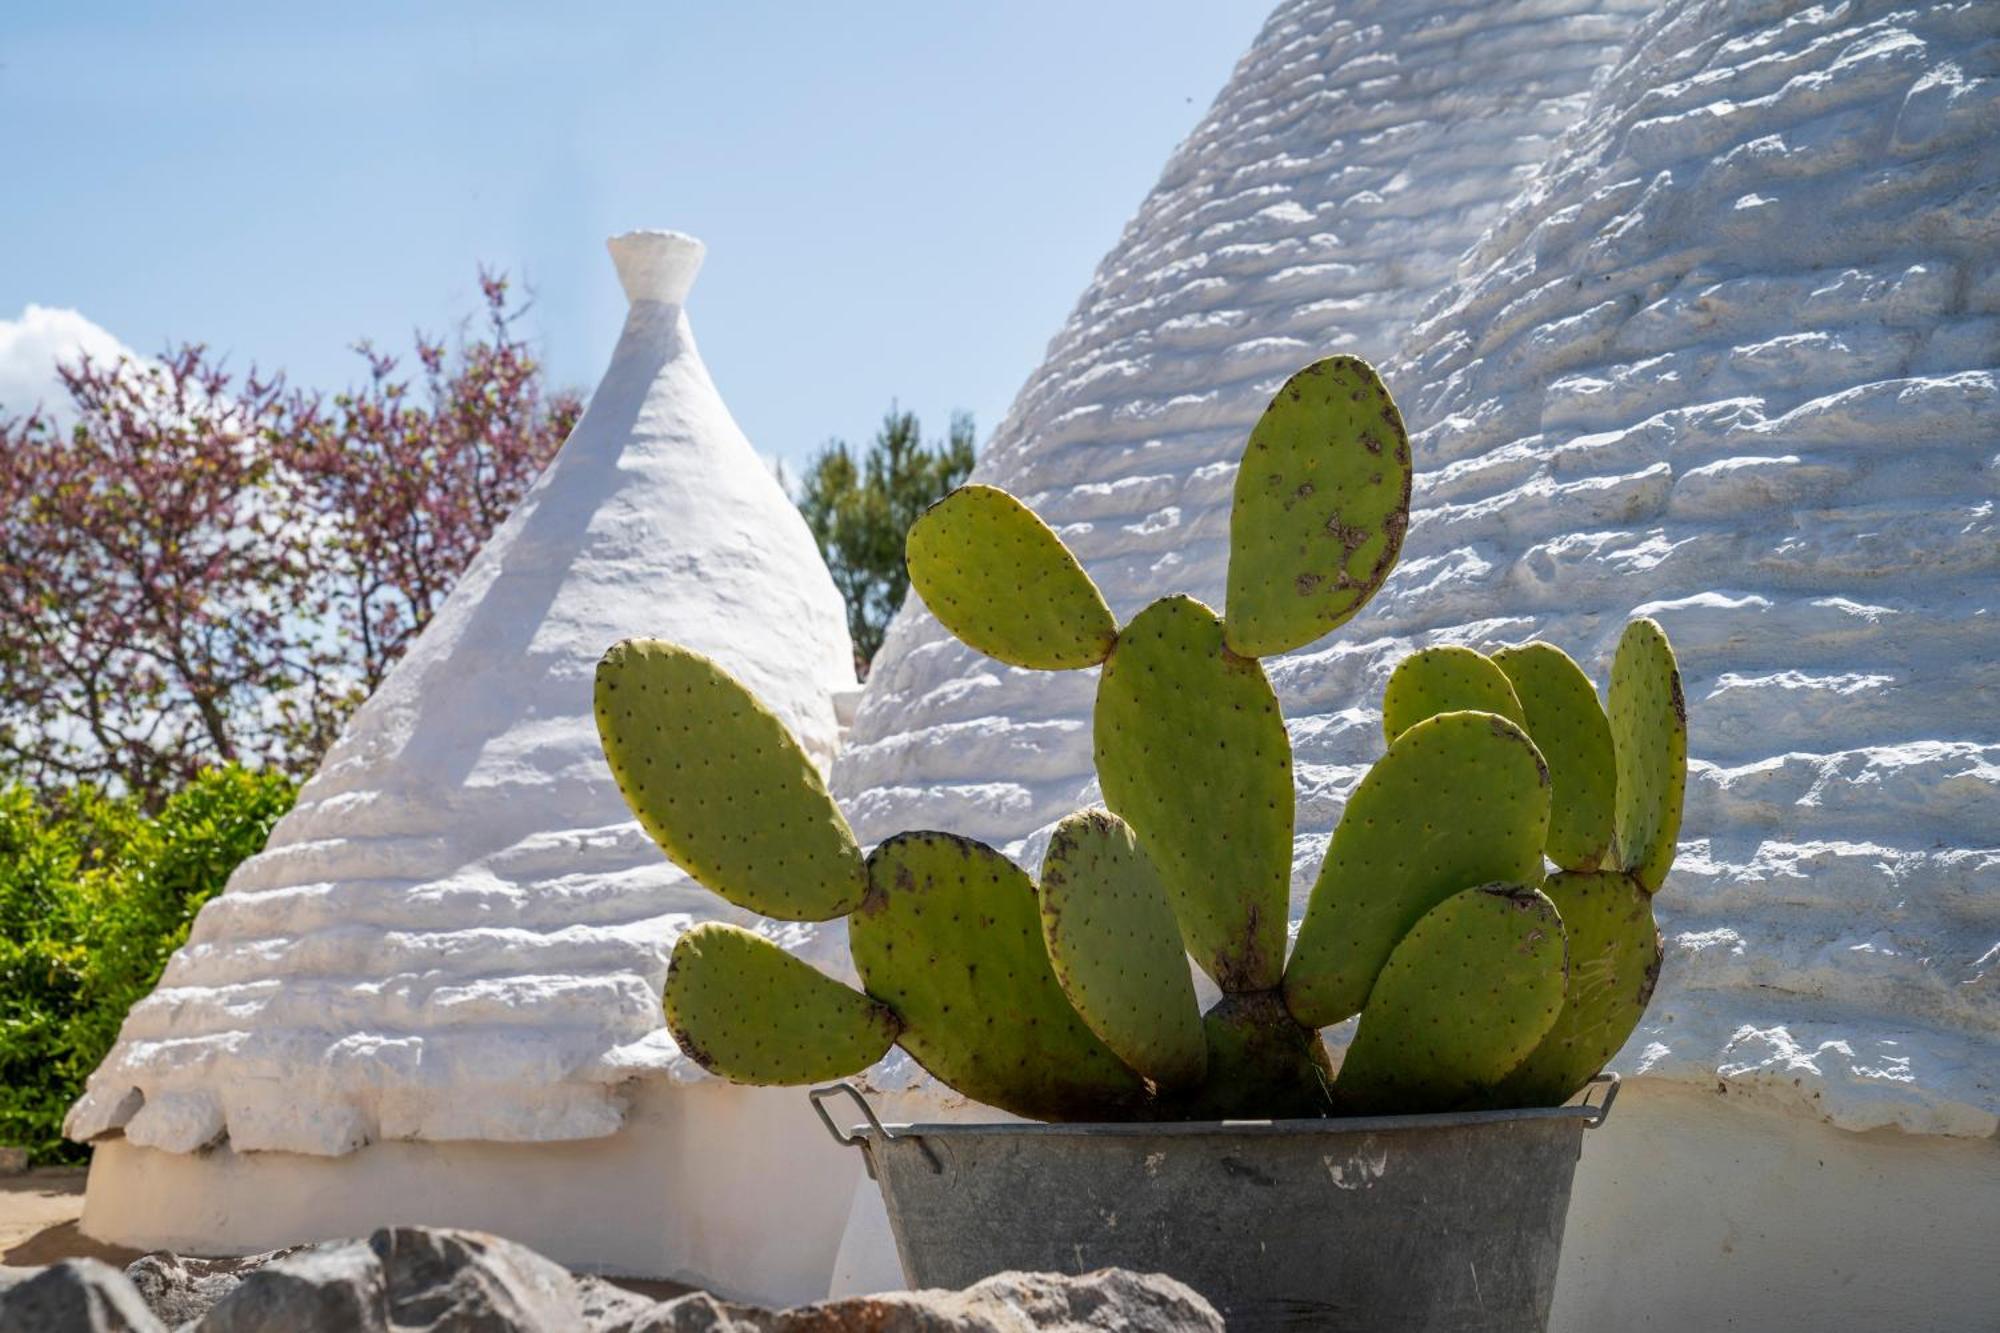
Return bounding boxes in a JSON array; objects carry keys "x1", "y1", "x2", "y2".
[{"x1": 1492, "y1": 871, "x2": 1662, "y2": 1107}]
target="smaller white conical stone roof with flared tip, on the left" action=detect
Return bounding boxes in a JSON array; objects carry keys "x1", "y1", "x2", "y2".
[{"x1": 68, "y1": 232, "x2": 854, "y2": 1153}]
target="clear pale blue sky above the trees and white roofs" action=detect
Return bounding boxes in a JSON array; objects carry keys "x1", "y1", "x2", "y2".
[{"x1": 0, "y1": 0, "x2": 1268, "y2": 472}]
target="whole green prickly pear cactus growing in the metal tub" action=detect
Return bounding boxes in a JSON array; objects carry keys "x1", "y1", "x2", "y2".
[{"x1": 596, "y1": 356, "x2": 1688, "y2": 1123}]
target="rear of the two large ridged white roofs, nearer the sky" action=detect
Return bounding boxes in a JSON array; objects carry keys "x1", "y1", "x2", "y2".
[{"x1": 834, "y1": 0, "x2": 1646, "y2": 845}]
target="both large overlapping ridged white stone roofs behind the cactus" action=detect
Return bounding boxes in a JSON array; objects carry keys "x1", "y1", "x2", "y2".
[{"x1": 834, "y1": 0, "x2": 2000, "y2": 1137}]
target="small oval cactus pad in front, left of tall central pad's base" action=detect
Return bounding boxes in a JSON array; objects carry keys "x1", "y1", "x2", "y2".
[{"x1": 1042, "y1": 811, "x2": 1208, "y2": 1089}]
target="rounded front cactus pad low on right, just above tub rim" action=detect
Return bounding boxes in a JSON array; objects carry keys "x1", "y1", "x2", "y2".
[{"x1": 1334, "y1": 885, "x2": 1564, "y2": 1115}]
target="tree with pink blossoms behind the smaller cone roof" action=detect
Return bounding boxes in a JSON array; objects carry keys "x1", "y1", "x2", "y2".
[{"x1": 0, "y1": 274, "x2": 580, "y2": 801}]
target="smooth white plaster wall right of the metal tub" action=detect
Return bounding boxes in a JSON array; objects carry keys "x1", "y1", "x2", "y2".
[{"x1": 1548, "y1": 1079, "x2": 2000, "y2": 1333}]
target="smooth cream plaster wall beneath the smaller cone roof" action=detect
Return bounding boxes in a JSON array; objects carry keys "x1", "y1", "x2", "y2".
[{"x1": 82, "y1": 1079, "x2": 866, "y2": 1305}]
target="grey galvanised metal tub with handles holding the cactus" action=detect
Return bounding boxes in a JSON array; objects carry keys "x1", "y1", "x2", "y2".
[{"x1": 812, "y1": 1075, "x2": 1618, "y2": 1333}]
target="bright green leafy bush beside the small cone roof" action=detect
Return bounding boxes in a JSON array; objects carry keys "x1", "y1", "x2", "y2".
[{"x1": 0, "y1": 767, "x2": 294, "y2": 1161}]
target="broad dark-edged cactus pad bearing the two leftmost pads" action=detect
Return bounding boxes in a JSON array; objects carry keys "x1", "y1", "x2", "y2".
[{"x1": 848, "y1": 833, "x2": 1144, "y2": 1121}]
